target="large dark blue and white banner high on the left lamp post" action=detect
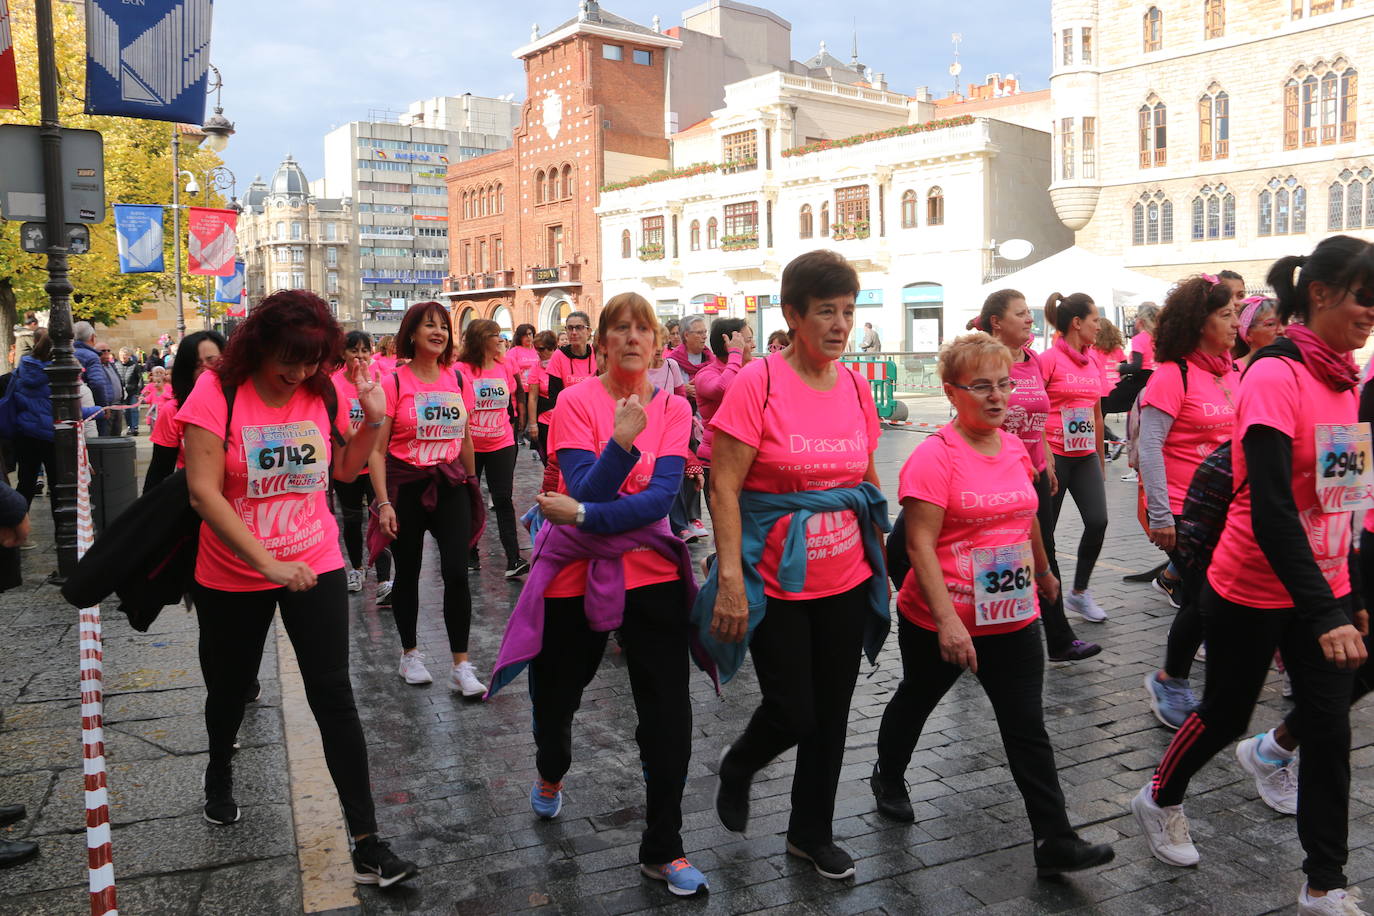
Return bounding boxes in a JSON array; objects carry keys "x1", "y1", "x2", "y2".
[{"x1": 85, "y1": 0, "x2": 212, "y2": 124}]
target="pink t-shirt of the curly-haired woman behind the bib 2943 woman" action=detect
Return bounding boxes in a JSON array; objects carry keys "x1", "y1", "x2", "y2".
[{"x1": 1140, "y1": 360, "x2": 1241, "y2": 515}]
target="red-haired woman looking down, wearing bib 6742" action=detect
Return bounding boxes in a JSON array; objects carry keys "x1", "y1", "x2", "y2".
[{"x1": 177, "y1": 290, "x2": 418, "y2": 887}]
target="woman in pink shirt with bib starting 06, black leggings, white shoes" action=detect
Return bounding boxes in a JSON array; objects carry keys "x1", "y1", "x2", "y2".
[{"x1": 1040, "y1": 293, "x2": 1107, "y2": 623}]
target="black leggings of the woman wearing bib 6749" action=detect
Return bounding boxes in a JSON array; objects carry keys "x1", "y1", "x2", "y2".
[{"x1": 392, "y1": 481, "x2": 473, "y2": 652}]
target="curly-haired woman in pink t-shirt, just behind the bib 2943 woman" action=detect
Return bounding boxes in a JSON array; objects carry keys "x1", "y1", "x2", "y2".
[{"x1": 1136, "y1": 275, "x2": 1241, "y2": 728}]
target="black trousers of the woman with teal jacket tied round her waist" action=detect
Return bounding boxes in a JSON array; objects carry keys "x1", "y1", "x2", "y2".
[{"x1": 721, "y1": 584, "x2": 871, "y2": 849}]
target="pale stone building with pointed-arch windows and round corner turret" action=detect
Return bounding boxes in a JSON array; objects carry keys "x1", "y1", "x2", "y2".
[{"x1": 1050, "y1": 0, "x2": 1374, "y2": 288}]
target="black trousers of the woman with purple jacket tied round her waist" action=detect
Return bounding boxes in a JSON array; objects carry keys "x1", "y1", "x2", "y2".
[{"x1": 529, "y1": 582, "x2": 691, "y2": 865}]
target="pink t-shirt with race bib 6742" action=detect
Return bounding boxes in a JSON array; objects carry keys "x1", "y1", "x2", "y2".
[{"x1": 177, "y1": 372, "x2": 348, "y2": 592}]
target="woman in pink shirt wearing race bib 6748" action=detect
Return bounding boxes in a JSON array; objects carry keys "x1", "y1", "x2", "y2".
[{"x1": 458, "y1": 319, "x2": 529, "y2": 578}]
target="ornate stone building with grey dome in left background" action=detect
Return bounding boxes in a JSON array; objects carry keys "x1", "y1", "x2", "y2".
[{"x1": 239, "y1": 155, "x2": 363, "y2": 330}]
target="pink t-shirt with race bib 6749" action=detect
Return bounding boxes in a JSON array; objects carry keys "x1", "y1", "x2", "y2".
[{"x1": 382, "y1": 365, "x2": 473, "y2": 467}]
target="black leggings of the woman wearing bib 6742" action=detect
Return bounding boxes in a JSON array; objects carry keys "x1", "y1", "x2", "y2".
[{"x1": 192, "y1": 570, "x2": 376, "y2": 836}]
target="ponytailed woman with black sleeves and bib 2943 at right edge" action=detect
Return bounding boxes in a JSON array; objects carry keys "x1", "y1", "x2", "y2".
[{"x1": 1131, "y1": 235, "x2": 1374, "y2": 913}]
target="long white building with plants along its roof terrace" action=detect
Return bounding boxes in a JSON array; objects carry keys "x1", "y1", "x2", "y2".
[{"x1": 596, "y1": 73, "x2": 1072, "y2": 352}]
